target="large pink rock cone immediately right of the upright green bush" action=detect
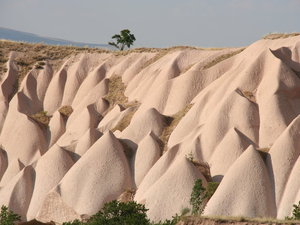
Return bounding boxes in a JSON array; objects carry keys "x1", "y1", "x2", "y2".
[{"x1": 204, "y1": 146, "x2": 276, "y2": 217}]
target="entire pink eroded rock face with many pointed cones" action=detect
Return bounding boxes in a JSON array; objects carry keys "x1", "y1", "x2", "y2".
[{"x1": 0, "y1": 37, "x2": 300, "y2": 223}]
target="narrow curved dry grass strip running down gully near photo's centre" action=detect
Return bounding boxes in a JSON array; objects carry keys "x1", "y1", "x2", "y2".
[{"x1": 160, "y1": 104, "x2": 193, "y2": 152}]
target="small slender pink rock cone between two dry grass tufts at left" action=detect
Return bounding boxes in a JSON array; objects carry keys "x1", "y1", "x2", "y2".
[{"x1": 49, "y1": 111, "x2": 66, "y2": 148}]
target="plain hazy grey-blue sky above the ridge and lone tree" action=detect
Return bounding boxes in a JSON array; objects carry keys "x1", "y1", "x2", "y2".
[{"x1": 0, "y1": 0, "x2": 300, "y2": 47}]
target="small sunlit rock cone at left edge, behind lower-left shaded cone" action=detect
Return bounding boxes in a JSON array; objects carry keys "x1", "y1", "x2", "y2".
[{"x1": 0, "y1": 159, "x2": 24, "y2": 187}]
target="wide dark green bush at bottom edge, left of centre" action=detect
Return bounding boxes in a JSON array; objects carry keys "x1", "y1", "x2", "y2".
[{"x1": 88, "y1": 201, "x2": 150, "y2": 225}]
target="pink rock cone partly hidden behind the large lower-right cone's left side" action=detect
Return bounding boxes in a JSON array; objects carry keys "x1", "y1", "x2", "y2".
[{"x1": 209, "y1": 128, "x2": 254, "y2": 182}]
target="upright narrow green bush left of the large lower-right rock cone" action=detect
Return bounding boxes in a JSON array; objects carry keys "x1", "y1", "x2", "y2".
[{"x1": 190, "y1": 179, "x2": 206, "y2": 215}]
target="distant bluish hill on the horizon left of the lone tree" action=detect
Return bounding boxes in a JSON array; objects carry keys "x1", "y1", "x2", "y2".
[{"x1": 0, "y1": 27, "x2": 111, "y2": 49}]
